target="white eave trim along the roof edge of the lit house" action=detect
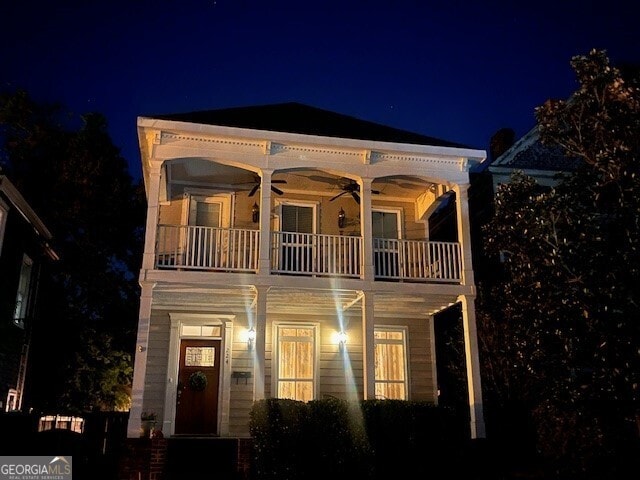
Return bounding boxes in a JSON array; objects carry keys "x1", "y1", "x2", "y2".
[{"x1": 137, "y1": 116, "x2": 487, "y2": 163}]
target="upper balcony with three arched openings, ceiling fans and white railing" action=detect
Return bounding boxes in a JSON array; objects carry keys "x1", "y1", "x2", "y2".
[{"x1": 153, "y1": 163, "x2": 463, "y2": 284}]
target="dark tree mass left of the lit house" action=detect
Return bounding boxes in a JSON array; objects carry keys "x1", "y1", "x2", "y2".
[{"x1": 0, "y1": 91, "x2": 144, "y2": 410}]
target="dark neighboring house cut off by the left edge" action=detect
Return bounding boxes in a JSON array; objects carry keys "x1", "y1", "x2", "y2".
[{"x1": 0, "y1": 173, "x2": 57, "y2": 412}]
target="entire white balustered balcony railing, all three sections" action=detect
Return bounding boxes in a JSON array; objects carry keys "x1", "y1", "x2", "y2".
[{"x1": 156, "y1": 225, "x2": 461, "y2": 282}]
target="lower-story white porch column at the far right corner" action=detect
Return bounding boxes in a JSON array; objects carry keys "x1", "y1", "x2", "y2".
[{"x1": 458, "y1": 295, "x2": 486, "y2": 438}]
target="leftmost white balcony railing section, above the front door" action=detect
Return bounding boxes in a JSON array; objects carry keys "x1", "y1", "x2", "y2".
[{"x1": 156, "y1": 225, "x2": 260, "y2": 272}]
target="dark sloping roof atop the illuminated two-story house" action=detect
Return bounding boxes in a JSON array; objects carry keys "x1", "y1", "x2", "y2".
[{"x1": 150, "y1": 102, "x2": 471, "y2": 148}]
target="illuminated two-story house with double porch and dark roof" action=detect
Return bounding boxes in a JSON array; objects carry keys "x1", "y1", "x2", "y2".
[{"x1": 128, "y1": 103, "x2": 486, "y2": 438}]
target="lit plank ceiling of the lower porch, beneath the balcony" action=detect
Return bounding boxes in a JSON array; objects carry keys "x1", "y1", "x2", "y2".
[{"x1": 153, "y1": 285, "x2": 456, "y2": 317}]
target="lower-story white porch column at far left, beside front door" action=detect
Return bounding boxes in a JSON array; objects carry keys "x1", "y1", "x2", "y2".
[{"x1": 127, "y1": 282, "x2": 155, "y2": 438}]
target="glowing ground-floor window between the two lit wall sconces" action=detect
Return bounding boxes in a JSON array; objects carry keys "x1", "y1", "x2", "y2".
[{"x1": 275, "y1": 324, "x2": 316, "y2": 402}]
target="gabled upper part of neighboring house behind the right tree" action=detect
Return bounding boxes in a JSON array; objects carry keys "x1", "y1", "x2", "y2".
[{"x1": 488, "y1": 127, "x2": 581, "y2": 191}]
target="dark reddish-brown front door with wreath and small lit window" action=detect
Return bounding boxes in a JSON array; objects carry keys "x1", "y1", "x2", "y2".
[{"x1": 175, "y1": 339, "x2": 221, "y2": 435}]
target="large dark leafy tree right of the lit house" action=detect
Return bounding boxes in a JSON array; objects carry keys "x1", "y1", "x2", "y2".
[{"x1": 479, "y1": 50, "x2": 640, "y2": 478}]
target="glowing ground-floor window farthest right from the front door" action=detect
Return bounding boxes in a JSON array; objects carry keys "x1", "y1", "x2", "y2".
[{"x1": 374, "y1": 327, "x2": 407, "y2": 400}]
